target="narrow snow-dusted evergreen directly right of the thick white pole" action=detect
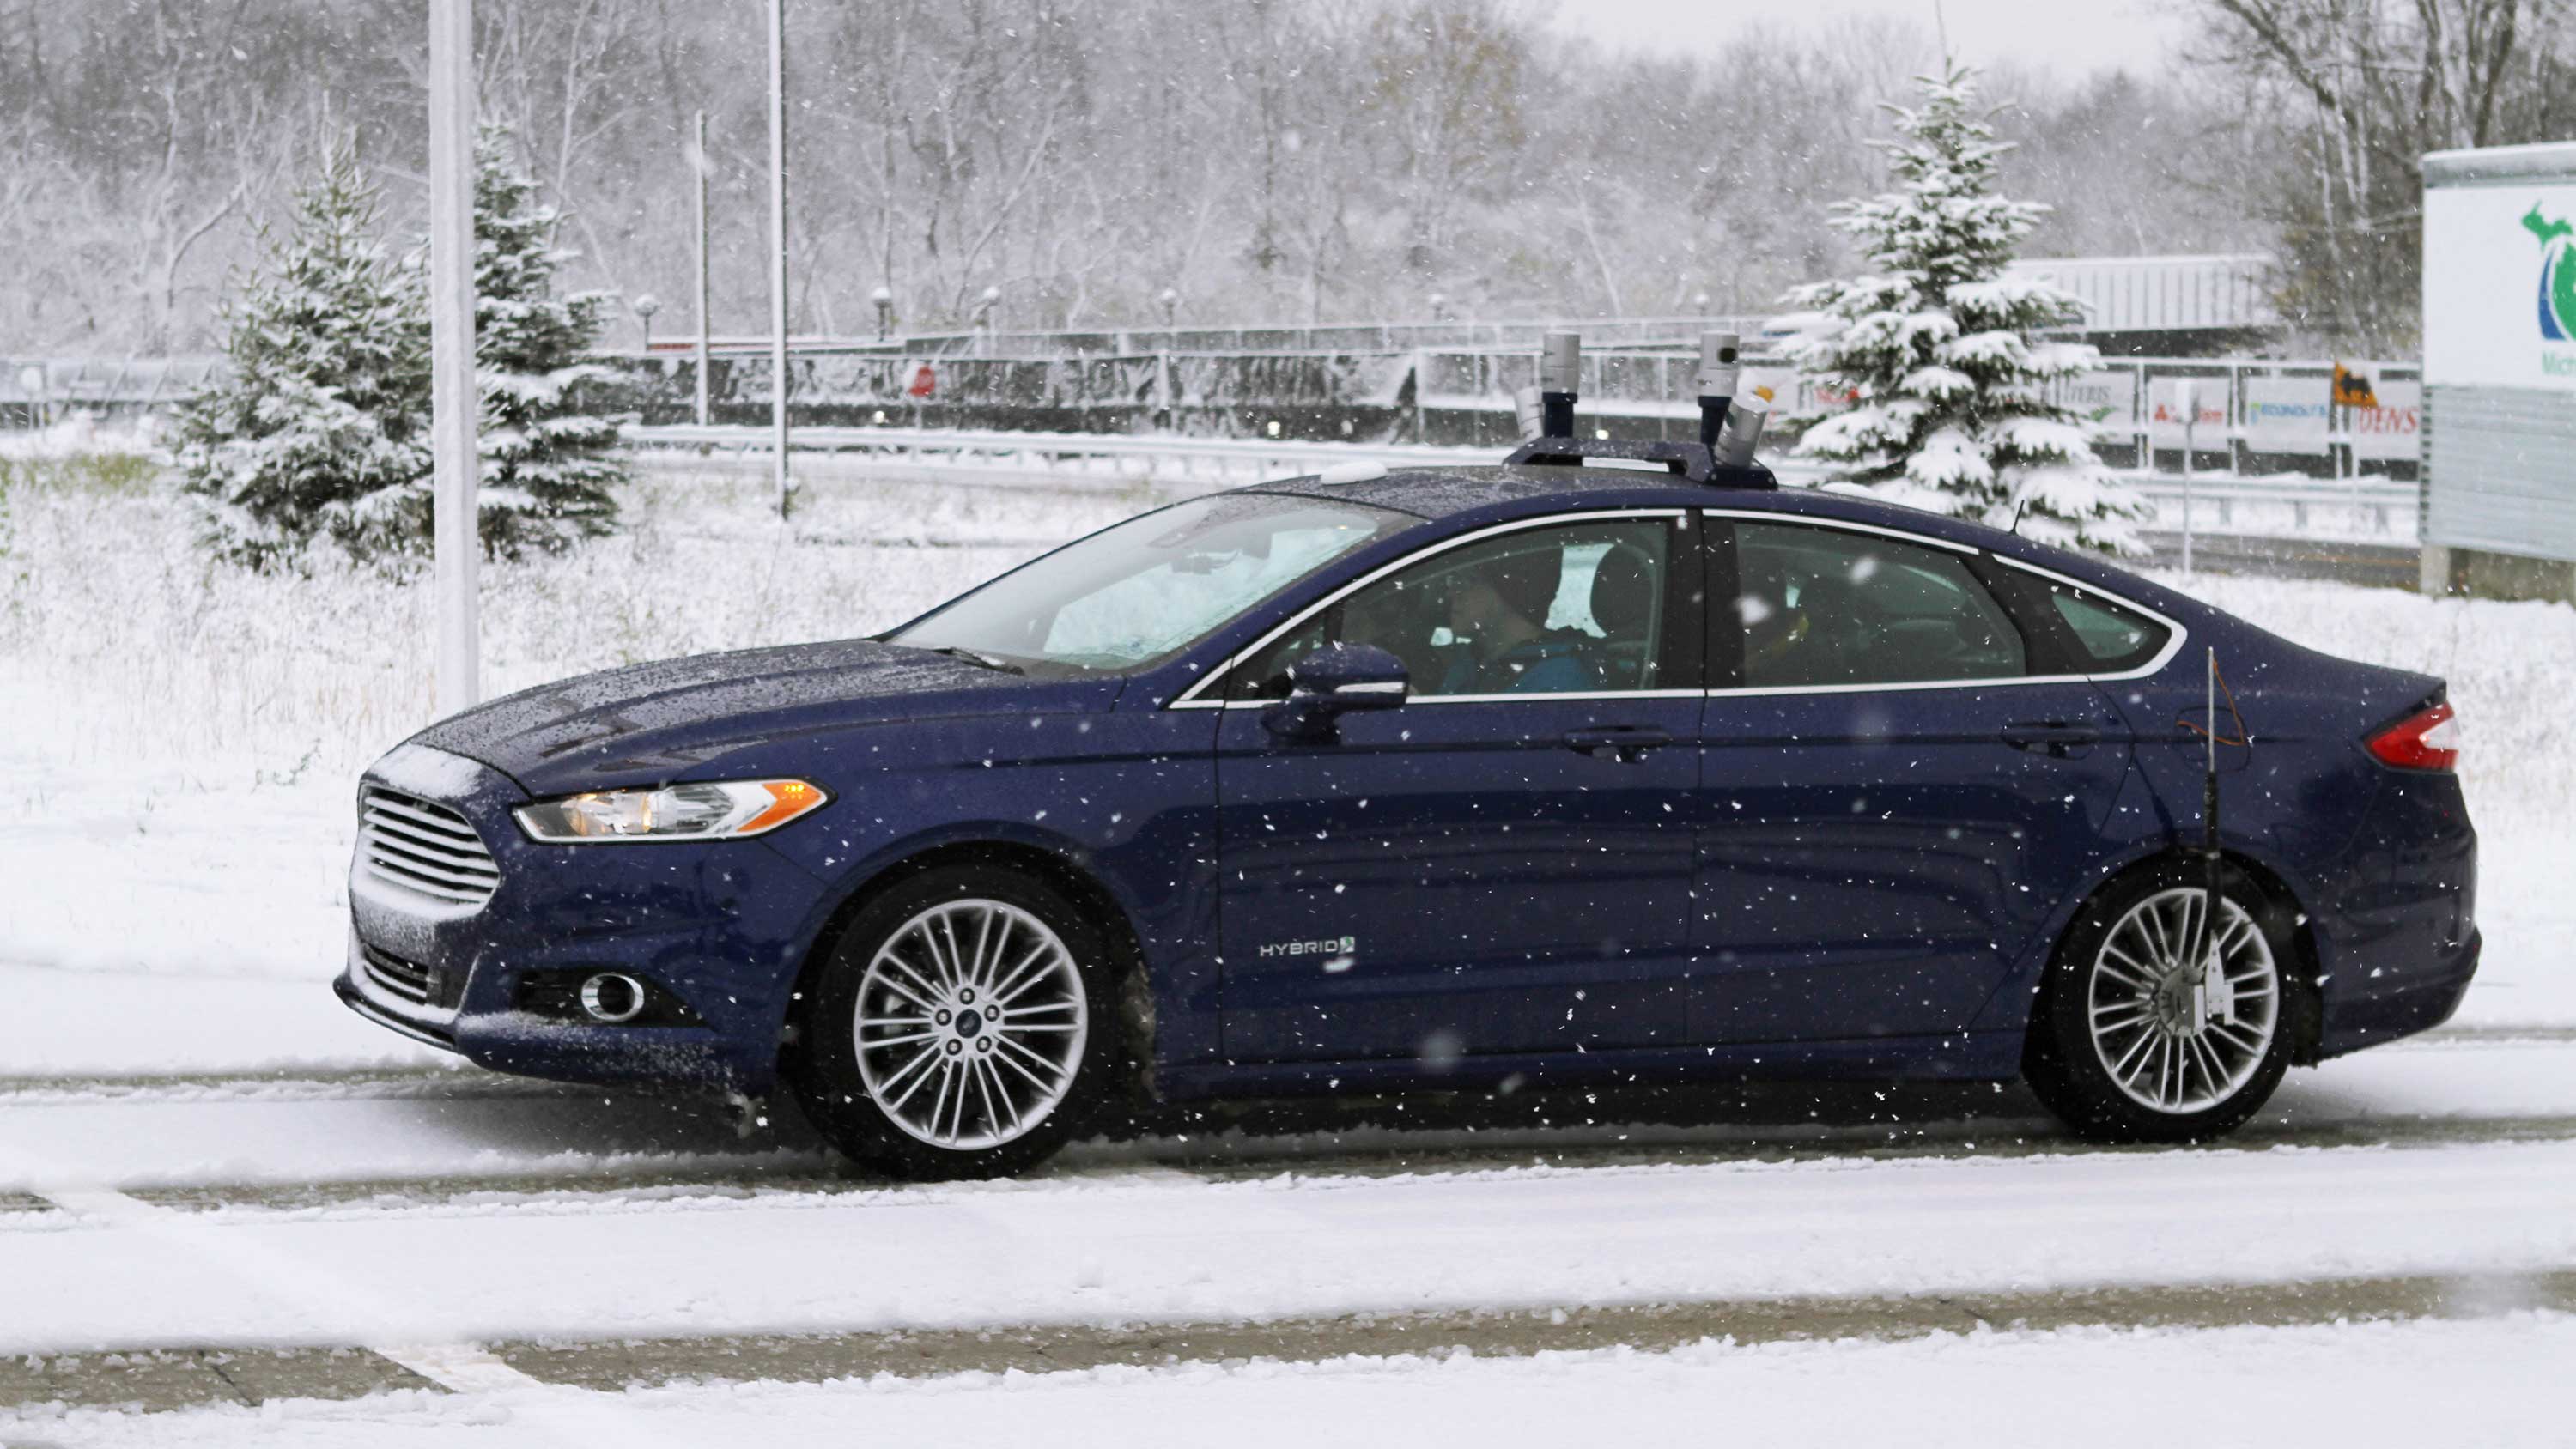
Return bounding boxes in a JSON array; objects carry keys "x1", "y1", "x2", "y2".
[{"x1": 474, "y1": 126, "x2": 626, "y2": 554}]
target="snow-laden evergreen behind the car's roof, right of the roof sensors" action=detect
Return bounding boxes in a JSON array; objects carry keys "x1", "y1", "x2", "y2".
[{"x1": 1780, "y1": 62, "x2": 2148, "y2": 554}]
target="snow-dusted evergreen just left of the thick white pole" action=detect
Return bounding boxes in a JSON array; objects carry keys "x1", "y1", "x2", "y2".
[{"x1": 175, "y1": 142, "x2": 430, "y2": 567}]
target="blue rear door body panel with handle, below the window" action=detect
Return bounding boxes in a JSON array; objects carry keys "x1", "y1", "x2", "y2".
[{"x1": 1692, "y1": 682, "x2": 2128, "y2": 1042}]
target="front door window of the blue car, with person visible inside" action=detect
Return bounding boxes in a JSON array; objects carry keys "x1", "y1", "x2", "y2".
[{"x1": 1226, "y1": 518, "x2": 1672, "y2": 700}]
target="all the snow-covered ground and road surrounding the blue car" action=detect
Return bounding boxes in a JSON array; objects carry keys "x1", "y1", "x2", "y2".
[{"x1": 0, "y1": 421, "x2": 2576, "y2": 1446}]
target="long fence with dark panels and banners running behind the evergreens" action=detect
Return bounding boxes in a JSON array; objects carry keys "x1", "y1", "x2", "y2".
[{"x1": 0, "y1": 342, "x2": 2424, "y2": 479}]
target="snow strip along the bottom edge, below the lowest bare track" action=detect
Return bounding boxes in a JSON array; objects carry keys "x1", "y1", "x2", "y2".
[{"x1": 20, "y1": 1313, "x2": 2576, "y2": 1449}]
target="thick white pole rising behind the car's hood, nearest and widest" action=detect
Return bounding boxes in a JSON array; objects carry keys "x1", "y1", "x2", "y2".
[{"x1": 430, "y1": 0, "x2": 482, "y2": 716}]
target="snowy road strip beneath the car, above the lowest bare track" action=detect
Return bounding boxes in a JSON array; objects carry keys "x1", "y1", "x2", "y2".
[{"x1": 0, "y1": 1040, "x2": 2576, "y2": 1354}]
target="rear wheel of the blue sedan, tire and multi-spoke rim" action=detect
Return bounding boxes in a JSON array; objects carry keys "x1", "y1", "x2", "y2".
[{"x1": 2022, "y1": 862, "x2": 2311, "y2": 1143}]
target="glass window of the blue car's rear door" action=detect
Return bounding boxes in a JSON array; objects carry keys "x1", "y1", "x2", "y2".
[{"x1": 1734, "y1": 523, "x2": 2030, "y2": 690}]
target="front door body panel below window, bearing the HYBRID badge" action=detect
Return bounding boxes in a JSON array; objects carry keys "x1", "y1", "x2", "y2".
[{"x1": 1216, "y1": 695, "x2": 1700, "y2": 1060}]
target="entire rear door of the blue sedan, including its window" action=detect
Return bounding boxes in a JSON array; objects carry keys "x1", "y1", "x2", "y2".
[{"x1": 1692, "y1": 515, "x2": 2130, "y2": 1042}]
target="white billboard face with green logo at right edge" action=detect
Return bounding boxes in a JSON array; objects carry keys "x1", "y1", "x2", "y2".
[{"x1": 2424, "y1": 183, "x2": 2576, "y2": 391}]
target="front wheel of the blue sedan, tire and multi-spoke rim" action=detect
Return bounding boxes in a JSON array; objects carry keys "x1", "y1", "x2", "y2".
[{"x1": 786, "y1": 864, "x2": 1121, "y2": 1181}]
